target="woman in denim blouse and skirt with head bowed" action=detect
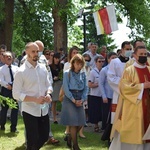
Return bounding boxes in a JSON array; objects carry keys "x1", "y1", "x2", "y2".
[{"x1": 60, "y1": 54, "x2": 88, "y2": 150}]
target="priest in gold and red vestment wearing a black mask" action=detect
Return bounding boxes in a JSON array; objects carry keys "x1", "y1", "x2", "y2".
[{"x1": 109, "y1": 46, "x2": 150, "y2": 150}]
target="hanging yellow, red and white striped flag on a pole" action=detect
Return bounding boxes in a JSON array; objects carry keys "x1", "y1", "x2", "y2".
[{"x1": 93, "y1": 5, "x2": 118, "y2": 35}]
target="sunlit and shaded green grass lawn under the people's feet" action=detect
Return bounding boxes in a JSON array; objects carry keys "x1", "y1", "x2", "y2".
[{"x1": 0, "y1": 102, "x2": 108, "y2": 150}]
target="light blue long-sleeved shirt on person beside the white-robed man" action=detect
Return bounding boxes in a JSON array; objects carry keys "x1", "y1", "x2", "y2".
[{"x1": 100, "y1": 65, "x2": 113, "y2": 99}]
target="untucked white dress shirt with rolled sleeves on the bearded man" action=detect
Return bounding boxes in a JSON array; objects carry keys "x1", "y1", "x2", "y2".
[{"x1": 13, "y1": 60, "x2": 52, "y2": 117}]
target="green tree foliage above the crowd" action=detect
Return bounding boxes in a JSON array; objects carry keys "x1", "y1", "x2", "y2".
[{"x1": 0, "y1": 0, "x2": 150, "y2": 54}]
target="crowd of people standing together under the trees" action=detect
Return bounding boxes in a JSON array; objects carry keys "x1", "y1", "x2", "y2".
[{"x1": 0, "y1": 40, "x2": 150, "y2": 150}]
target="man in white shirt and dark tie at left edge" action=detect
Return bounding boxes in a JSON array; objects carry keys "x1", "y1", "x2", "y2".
[{"x1": 0, "y1": 51, "x2": 18, "y2": 133}]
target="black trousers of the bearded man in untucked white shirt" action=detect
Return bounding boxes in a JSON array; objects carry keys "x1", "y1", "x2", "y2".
[{"x1": 22, "y1": 112, "x2": 49, "y2": 150}]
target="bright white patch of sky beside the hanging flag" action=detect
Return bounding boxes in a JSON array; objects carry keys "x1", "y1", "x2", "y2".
[{"x1": 111, "y1": 18, "x2": 131, "y2": 49}]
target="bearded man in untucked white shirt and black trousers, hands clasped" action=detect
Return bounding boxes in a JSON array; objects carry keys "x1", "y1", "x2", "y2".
[{"x1": 13, "y1": 42, "x2": 52, "y2": 150}]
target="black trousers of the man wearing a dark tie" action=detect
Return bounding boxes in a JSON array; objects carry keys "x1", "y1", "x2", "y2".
[{"x1": 0, "y1": 87, "x2": 18, "y2": 132}]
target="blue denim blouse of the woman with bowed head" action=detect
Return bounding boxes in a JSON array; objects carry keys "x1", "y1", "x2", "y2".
[{"x1": 63, "y1": 69, "x2": 88, "y2": 101}]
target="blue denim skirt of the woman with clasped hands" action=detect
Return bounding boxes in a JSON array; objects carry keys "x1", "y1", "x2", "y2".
[{"x1": 60, "y1": 91, "x2": 85, "y2": 126}]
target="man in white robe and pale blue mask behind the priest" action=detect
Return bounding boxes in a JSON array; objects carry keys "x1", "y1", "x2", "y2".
[{"x1": 107, "y1": 41, "x2": 132, "y2": 124}]
